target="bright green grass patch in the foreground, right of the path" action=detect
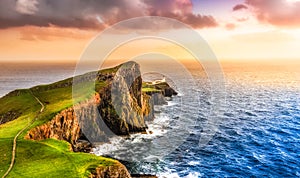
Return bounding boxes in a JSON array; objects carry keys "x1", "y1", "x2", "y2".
[{"x1": 8, "y1": 139, "x2": 117, "y2": 177}]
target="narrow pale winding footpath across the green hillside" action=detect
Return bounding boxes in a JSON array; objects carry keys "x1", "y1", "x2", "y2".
[{"x1": 2, "y1": 91, "x2": 45, "y2": 178}]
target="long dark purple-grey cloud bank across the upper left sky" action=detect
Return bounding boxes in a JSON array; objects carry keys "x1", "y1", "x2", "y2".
[{"x1": 0, "y1": 0, "x2": 217, "y2": 29}]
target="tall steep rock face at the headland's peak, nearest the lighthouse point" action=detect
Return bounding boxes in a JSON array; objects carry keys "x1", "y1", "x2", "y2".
[{"x1": 98, "y1": 62, "x2": 149, "y2": 135}]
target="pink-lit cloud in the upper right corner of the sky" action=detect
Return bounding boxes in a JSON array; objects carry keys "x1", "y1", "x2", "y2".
[{"x1": 246, "y1": 0, "x2": 300, "y2": 28}]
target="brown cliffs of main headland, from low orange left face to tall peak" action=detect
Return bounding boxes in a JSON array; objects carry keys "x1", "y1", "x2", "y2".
[{"x1": 26, "y1": 62, "x2": 158, "y2": 145}]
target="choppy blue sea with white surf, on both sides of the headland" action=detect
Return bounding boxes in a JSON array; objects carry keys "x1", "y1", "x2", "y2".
[{"x1": 0, "y1": 60, "x2": 300, "y2": 178}]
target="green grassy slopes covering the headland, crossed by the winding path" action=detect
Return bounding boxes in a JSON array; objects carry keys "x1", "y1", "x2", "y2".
[{"x1": 0, "y1": 69, "x2": 116, "y2": 177}]
